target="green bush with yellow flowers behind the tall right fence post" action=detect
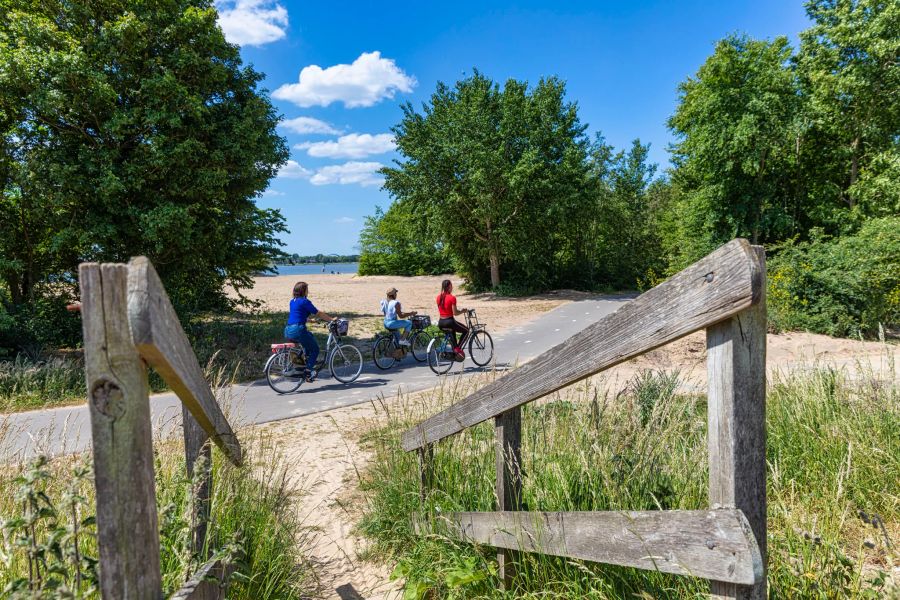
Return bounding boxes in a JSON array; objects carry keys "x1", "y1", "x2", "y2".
[{"x1": 768, "y1": 217, "x2": 900, "y2": 336}]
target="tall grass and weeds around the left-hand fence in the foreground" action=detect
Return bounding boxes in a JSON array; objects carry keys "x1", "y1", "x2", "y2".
[{"x1": 0, "y1": 368, "x2": 316, "y2": 600}]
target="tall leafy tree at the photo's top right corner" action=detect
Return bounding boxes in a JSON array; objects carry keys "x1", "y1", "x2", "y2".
[{"x1": 796, "y1": 0, "x2": 900, "y2": 221}]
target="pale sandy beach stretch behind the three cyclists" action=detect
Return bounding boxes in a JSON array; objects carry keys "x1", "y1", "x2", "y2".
[{"x1": 230, "y1": 274, "x2": 589, "y2": 337}]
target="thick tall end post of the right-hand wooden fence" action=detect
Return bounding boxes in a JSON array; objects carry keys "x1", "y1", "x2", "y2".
[{"x1": 706, "y1": 246, "x2": 766, "y2": 600}]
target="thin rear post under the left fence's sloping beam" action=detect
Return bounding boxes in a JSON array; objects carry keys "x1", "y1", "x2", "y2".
[{"x1": 181, "y1": 404, "x2": 212, "y2": 560}]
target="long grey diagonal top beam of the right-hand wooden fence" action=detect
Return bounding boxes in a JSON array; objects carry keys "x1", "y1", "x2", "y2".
[{"x1": 402, "y1": 239, "x2": 765, "y2": 451}]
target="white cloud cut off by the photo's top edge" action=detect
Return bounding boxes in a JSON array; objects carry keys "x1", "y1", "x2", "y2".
[{"x1": 216, "y1": 0, "x2": 288, "y2": 46}]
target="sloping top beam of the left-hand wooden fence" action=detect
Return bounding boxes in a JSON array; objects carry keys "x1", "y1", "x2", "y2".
[{"x1": 128, "y1": 256, "x2": 242, "y2": 465}]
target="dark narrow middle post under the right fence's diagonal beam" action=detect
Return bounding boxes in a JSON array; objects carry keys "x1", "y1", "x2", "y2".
[{"x1": 494, "y1": 406, "x2": 522, "y2": 590}]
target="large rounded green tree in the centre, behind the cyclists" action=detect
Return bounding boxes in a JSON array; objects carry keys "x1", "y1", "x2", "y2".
[{"x1": 383, "y1": 71, "x2": 587, "y2": 287}]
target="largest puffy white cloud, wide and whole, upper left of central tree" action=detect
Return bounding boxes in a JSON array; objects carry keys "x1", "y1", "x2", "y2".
[{"x1": 272, "y1": 52, "x2": 416, "y2": 108}]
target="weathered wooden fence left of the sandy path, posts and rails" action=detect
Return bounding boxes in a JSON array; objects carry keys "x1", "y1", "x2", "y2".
[{"x1": 79, "y1": 257, "x2": 241, "y2": 600}]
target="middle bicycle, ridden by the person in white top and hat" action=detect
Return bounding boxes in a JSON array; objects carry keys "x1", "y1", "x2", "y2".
[{"x1": 264, "y1": 319, "x2": 362, "y2": 394}]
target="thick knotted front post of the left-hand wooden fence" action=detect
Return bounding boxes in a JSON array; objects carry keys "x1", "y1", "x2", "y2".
[{"x1": 79, "y1": 263, "x2": 162, "y2": 600}]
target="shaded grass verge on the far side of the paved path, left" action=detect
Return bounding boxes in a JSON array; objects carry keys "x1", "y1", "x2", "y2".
[{"x1": 0, "y1": 312, "x2": 372, "y2": 412}]
